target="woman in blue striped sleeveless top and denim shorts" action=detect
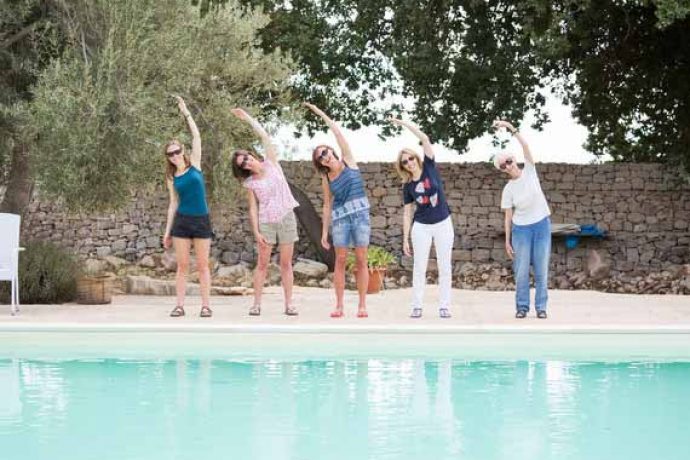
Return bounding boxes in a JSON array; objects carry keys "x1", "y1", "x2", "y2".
[{"x1": 304, "y1": 103, "x2": 371, "y2": 318}]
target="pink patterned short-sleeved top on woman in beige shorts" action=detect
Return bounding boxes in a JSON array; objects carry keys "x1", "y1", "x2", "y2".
[{"x1": 243, "y1": 160, "x2": 299, "y2": 224}]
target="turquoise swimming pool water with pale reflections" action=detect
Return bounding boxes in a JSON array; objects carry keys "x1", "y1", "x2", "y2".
[{"x1": 0, "y1": 358, "x2": 690, "y2": 460}]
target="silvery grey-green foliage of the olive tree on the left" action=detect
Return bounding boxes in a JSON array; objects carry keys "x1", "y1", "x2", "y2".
[{"x1": 26, "y1": 0, "x2": 291, "y2": 210}]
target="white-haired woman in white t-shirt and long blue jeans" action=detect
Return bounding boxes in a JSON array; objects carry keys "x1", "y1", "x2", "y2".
[{"x1": 494, "y1": 120, "x2": 551, "y2": 319}]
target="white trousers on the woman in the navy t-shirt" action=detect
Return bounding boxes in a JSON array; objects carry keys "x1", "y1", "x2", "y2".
[{"x1": 410, "y1": 216, "x2": 455, "y2": 308}]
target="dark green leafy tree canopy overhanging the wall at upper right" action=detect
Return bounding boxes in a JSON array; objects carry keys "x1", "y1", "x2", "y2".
[{"x1": 196, "y1": 0, "x2": 690, "y2": 171}]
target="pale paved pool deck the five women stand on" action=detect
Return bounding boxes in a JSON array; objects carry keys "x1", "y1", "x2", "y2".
[{"x1": 0, "y1": 286, "x2": 690, "y2": 334}]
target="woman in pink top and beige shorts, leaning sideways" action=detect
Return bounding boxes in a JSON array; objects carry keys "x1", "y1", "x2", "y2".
[{"x1": 232, "y1": 109, "x2": 299, "y2": 316}]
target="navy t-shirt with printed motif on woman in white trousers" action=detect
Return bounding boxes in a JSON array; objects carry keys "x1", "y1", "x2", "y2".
[{"x1": 403, "y1": 155, "x2": 450, "y2": 224}]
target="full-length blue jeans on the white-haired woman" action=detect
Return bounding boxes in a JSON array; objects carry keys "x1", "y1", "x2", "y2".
[{"x1": 511, "y1": 217, "x2": 551, "y2": 312}]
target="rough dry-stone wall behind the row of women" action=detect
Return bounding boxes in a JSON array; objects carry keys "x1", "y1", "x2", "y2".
[{"x1": 16, "y1": 162, "x2": 690, "y2": 288}]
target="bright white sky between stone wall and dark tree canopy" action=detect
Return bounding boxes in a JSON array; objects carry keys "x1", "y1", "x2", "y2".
[{"x1": 276, "y1": 91, "x2": 608, "y2": 164}]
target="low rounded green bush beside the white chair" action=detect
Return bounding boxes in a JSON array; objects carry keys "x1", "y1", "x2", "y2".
[{"x1": 0, "y1": 241, "x2": 79, "y2": 304}]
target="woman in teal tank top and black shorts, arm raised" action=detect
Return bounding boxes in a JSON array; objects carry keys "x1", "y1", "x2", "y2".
[{"x1": 163, "y1": 96, "x2": 212, "y2": 318}]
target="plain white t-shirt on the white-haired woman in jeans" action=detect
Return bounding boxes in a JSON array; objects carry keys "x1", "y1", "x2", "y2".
[{"x1": 501, "y1": 161, "x2": 551, "y2": 225}]
